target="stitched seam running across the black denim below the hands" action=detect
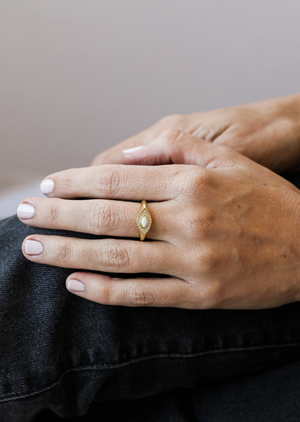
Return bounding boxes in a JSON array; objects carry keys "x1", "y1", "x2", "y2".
[{"x1": 0, "y1": 342, "x2": 300, "y2": 403}]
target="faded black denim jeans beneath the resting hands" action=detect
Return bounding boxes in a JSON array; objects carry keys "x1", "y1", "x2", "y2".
[{"x1": 0, "y1": 173, "x2": 300, "y2": 422}]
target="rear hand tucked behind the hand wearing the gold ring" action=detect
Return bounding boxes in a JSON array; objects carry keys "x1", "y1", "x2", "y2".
[{"x1": 92, "y1": 95, "x2": 300, "y2": 173}]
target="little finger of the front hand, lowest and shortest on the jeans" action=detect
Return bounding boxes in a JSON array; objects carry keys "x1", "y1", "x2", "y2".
[{"x1": 66, "y1": 273, "x2": 191, "y2": 308}]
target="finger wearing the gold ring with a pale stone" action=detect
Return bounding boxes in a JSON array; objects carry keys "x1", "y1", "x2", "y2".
[{"x1": 17, "y1": 198, "x2": 169, "y2": 240}]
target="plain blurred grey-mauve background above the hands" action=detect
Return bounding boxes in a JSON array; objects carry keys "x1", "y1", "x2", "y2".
[{"x1": 0, "y1": 0, "x2": 300, "y2": 218}]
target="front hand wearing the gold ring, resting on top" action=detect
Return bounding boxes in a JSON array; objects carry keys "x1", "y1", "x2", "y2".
[{"x1": 19, "y1": 130, "x2": 300, "y2": 309}]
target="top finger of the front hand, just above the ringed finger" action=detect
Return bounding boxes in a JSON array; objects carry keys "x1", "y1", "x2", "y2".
[{"x1": 41, "y1": 164, "x2": 185, "y2": 201}]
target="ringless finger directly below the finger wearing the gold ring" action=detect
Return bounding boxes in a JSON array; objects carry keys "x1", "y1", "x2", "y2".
[{"x1": 22, "y1": 235, "x2": 173, "y2": 274}]
